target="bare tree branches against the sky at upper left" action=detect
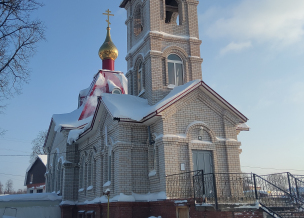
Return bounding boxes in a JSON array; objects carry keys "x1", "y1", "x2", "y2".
[{"x1": 0, "y1": 0, "x2": 44, "y2": 136}]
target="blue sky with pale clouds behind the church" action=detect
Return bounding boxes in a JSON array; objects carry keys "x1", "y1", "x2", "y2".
[{"x1": 0, "y1": 0, "x2": 304, "y2": 189}]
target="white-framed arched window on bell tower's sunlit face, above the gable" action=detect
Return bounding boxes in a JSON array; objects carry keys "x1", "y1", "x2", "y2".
[{"x1": 168, "y1": 54, "x2": 183, "y2": 86}]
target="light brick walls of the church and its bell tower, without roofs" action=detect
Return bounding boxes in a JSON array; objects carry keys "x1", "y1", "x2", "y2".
[{"x1": 46, "y1": 0, "x2": 246, "y2": 202}]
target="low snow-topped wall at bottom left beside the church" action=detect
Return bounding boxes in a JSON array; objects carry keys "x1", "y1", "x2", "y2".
[{"x1": 0, "y1": 193, "x2": 62, "y2": 218}]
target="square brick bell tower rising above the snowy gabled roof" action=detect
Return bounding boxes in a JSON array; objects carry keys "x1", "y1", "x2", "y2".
[{"x1": 120, "y1": 0, "x2": 203, "y2": 105}]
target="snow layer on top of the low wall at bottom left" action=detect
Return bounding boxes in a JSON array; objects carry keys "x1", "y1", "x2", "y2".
[{"x1": 0, "y1": 193, "x2": 62, "y2": 202}]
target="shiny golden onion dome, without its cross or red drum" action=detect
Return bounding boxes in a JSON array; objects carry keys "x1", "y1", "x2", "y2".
[{"x1": 98, "y1": 27, "x2": 118, "y2": 60}]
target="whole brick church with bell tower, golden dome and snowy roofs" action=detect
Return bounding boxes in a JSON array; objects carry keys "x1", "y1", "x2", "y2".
[{"x1": 44, "y1": 0, "x2": 249, "y2": 218}]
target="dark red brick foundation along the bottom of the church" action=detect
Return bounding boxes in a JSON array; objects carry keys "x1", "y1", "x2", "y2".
[{"x1": 61, "y1": 200, "x2": 263, "y2": 218}]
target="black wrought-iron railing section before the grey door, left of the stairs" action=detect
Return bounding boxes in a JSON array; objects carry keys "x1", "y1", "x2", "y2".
[{"x1": 166, "y1": 171, "x2": 256, "y2": 205}]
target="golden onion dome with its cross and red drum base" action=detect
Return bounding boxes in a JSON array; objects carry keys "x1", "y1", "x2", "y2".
[{"x1": 98, "y1": 9, "x2": 118, "y2": 70}]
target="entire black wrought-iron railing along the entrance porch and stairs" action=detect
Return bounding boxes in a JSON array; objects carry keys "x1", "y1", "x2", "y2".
[{"x1": 166, "y1": 170, "x2": 304, "y2": 217}]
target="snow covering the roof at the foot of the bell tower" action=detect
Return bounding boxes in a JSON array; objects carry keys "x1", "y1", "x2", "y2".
[{"x1": 102, "y1": 80, "x2": 200, "y2": 121}]
